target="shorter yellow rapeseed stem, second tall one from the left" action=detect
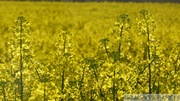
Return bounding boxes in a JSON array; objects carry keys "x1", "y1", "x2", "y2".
[{"x1": 55, "y1": 30, "x2": 74, "y2": 100}]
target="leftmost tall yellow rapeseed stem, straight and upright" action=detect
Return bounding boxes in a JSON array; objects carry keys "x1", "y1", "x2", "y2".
[{"x1": 8, "y1": 16, "x2": 30, "y2": 101}]
